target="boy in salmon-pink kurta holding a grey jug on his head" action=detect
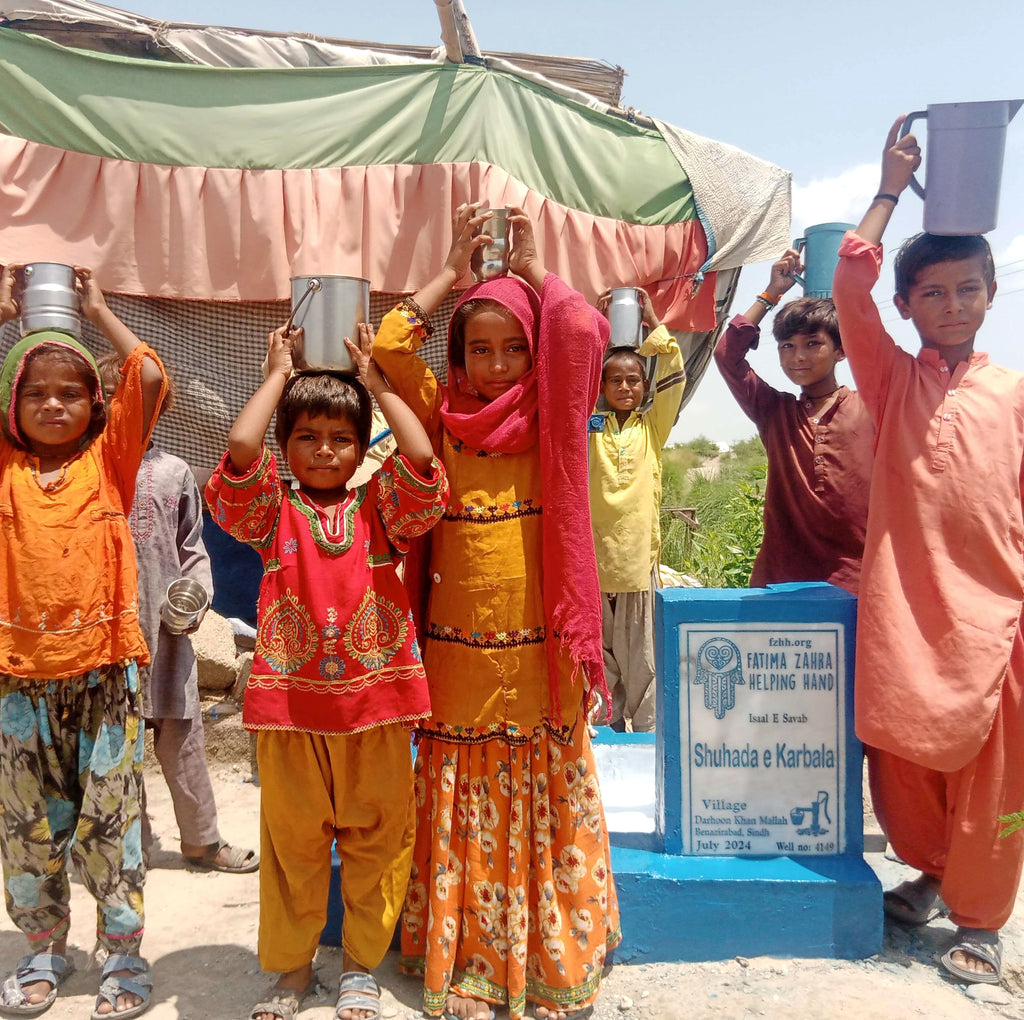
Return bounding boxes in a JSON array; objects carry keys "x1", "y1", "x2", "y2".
[{"x1": 834, "y1": 117, "x2": 1024, "y2": 983}]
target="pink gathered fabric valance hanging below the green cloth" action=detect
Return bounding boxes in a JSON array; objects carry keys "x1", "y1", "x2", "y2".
[{"x1": 0, "y1": 136, "x2": 715, "y2": 331}]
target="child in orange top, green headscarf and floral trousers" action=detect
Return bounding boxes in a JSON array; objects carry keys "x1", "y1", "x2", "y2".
[{"x1": 0, "y1": 266, "x2": 166, "y2": 1018}]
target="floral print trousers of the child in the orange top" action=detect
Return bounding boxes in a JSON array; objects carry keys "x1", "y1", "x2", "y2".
[{"x1": 0, "y1": 662, "x2": 145, "y2": 955}]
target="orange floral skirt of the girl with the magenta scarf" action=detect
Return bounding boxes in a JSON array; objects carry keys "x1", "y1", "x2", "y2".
[{"x1": 401, "y1": 718, "x2": 622, "y2": 1020}]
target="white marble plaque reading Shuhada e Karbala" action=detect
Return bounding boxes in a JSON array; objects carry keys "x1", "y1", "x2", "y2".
[{"x1": 679, "y1": 623, "x2": 847, "y2": 856}]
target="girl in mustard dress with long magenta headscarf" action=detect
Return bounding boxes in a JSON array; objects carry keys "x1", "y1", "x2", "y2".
[{"x1": 374, "y1": 205, "x2": 620, "y2": 1020}]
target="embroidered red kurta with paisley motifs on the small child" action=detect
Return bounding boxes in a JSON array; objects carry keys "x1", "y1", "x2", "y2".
[{"x1": 206, "y1": 450, "x2": 447, "y2": 733}]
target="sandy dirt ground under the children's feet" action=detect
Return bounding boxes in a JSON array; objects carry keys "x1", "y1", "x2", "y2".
[{"x1": 0, "y1": 715, "x2": 1024, "y2": 1020}]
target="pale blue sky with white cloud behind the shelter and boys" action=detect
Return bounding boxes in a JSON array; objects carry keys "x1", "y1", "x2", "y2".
[{"x1": 121, "y1": 0, "x2": 1024, "y2": 443}]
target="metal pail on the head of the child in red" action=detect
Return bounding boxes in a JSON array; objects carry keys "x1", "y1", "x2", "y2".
[{"x1": 289, "y1": 277, "x2": 370, "y2": 372}]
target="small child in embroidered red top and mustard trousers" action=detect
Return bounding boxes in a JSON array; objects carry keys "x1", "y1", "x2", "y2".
[{"x1": 206, "y1": 325, "x2": 447, "y2": 1020}]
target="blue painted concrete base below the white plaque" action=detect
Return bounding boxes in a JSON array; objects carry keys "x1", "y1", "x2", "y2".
[{"x1": 611, "y1": 846, "x2": 882, "y2": 963}]
